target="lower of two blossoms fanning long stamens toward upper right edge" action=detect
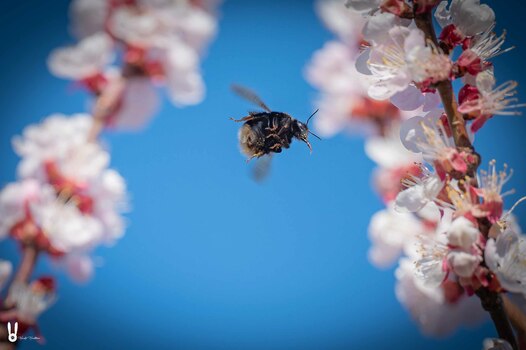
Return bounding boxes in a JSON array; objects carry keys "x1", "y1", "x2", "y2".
[{"x1": 458, "y1": 70, "x2": 524, "y2": 132}]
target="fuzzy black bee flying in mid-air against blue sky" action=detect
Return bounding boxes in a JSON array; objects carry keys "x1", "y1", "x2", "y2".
[{"x1": 230, "y1": 85, "x2": 319, "y2": 162}]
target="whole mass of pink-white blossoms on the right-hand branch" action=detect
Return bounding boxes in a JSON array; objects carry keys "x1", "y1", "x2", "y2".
[{"x1": 305, "y1": 0, "x2": 526, "y2": 346}]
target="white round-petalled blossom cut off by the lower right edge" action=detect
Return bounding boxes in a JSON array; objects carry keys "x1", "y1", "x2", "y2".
[{"x1": 485, "y1": 229, "x2": 526, "y2": 295}]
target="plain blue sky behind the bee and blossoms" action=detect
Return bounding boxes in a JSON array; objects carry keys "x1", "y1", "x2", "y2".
[{"x1": 0, "y1": 0, "x2": 526, "y2": 350}]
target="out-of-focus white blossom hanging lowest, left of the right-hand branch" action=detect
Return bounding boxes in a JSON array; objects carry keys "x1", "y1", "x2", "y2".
[{"x1": 395, "y1": 258, "x2": 486, "y2": 336}]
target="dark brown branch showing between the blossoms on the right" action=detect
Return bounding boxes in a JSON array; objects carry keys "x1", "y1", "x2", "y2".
[{"x1": 415, "y1": 6, "x2": 518, "y2": 350}]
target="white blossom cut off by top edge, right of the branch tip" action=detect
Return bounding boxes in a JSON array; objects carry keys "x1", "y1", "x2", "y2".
[{"x1": 435, "y1": 0, "x2": 495, "y2": 36}]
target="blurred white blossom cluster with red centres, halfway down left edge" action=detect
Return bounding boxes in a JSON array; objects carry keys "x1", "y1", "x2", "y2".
[{"x1": 0, "y1": 115, "x2": 126, "y2": 279}]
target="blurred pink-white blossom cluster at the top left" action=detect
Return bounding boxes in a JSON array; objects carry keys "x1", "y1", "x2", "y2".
[{"x1": 48, "y1": 0, "x2": 218, "y2": 130}]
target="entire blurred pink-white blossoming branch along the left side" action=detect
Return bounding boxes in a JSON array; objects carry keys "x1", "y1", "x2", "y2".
[{"x1": 0, "y1": 0, "x2": 218, "y2": 342}]
